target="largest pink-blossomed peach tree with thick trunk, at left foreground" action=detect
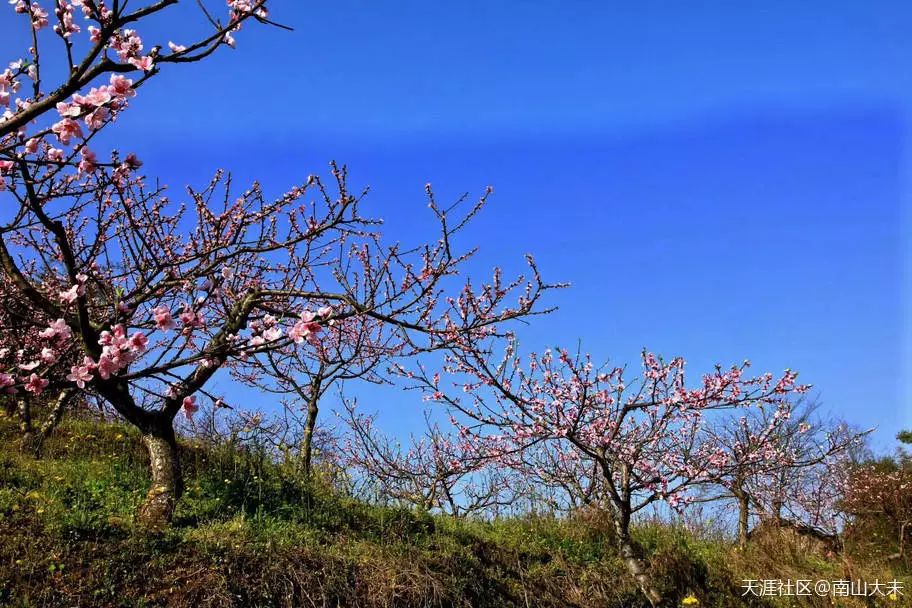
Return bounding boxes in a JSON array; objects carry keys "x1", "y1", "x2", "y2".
[{"x1": 0, "y1": 0, "x2": 549, "y2": 527}]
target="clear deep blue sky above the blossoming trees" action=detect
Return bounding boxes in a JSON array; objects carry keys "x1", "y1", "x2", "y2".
[{"x1": 0, "y1": 0, "x2": 912, "y2": 445}]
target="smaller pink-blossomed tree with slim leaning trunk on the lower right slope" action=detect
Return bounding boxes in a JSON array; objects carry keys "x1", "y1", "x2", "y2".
[{"x1": 403, "y1": 336, "x2": 807, "y2": 606}]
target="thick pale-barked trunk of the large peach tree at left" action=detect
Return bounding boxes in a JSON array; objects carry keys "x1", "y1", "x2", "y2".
[{"x1": 139, "y1": 420, "x2": 183, "y2": 529}]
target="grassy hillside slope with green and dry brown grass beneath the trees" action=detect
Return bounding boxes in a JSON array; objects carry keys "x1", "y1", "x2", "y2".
[{"x1": 0, "y1": 419, "x2": 912, "y2": 608}]
